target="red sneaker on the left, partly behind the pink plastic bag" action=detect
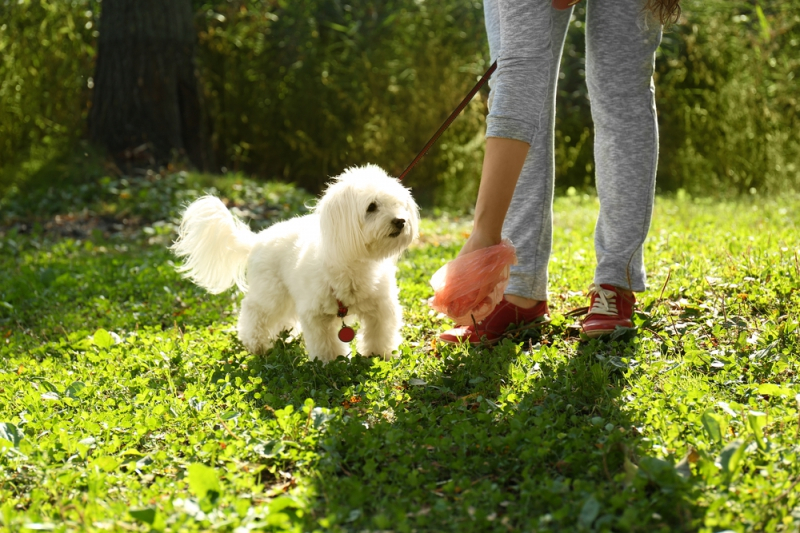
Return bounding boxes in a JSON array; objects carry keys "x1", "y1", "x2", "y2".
[{"x1": 439, "y1": 298, "x2": 550, "y2": 346}]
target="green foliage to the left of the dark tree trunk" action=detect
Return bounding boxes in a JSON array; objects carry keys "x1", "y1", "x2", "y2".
[{"x1": 0, "y1": 0, "x2": 100, "y2": 171}]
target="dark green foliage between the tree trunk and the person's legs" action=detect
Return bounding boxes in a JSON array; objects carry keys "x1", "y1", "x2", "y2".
[{"x1": 192, "y1": 0, "x2": 487, "y2": 206}]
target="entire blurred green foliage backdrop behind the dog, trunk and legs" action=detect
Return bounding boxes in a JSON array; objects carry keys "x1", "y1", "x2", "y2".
[{"x1": 0, "y1": 0, "x2": 800, "y2": 208}]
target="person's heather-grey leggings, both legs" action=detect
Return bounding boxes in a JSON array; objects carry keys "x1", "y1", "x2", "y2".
[{"x1": 484, "y1": 0, "x2": 661, "y2": 300}]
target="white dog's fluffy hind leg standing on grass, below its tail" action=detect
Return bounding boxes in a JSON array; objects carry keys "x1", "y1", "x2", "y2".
[{"x1": 239, "y1": 291, "x2": 296, "y2": 354}]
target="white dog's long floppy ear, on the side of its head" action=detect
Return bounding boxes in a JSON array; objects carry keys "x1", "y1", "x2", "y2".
[{"x1": 315, "y1": 181, "x2": 366, "y2": 264}]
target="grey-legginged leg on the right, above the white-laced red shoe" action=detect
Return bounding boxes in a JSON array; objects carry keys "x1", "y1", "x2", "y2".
[{"x1": 586, "y1": 0, "x2": 661, "y2": 291}]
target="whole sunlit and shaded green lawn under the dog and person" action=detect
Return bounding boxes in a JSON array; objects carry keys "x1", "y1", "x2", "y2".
[{"x1": 0, "y1": 174, "x2": 800, "y2": 532}]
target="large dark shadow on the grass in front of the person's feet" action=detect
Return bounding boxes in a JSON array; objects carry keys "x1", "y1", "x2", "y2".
[{"x1": 223, "y1": 326, "x2": 699, "y2": 531}]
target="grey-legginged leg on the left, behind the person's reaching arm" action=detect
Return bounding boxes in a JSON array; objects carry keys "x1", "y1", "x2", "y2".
[{"x1": 484, "y1": 0, "x2": 572, "y2": 300}]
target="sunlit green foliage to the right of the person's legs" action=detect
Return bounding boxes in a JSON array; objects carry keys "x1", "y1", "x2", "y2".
[{"x1": 658, "y1": 0, "x2": 800, "y2": 194}]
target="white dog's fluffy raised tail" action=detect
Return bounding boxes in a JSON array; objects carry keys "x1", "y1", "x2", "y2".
[{"x1": 172, "y1": 196, "x2": 256, "y2": 294}]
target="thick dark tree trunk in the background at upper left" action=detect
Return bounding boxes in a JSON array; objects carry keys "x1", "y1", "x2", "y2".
[{"x1": 89, "y1": 0, "x2": 209, "y2": 169}]
